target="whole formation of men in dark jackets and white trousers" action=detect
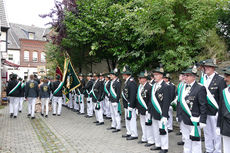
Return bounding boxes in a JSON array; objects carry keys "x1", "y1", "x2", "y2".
[{"x1": 7, "y1": 59, "x2": 230, "y2": 153}]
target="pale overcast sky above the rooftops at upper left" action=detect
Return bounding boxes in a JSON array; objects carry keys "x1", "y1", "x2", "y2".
[{"x1": 5, "y1": 0, "x2": 54, "y2": 27}]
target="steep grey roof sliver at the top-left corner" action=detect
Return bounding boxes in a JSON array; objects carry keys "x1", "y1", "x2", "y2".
[{"x1": 0, "y1": 0, "x2": 10, "y2": 28}]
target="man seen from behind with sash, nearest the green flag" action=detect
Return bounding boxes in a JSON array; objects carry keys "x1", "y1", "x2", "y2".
[{"x1": 51, "y1": 75, "x2": 63, "y2": 116}]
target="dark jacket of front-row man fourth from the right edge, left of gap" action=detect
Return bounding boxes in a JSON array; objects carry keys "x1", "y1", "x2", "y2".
[{"x1": 149, "y1": 81, "x2": 170, "y2": 120}]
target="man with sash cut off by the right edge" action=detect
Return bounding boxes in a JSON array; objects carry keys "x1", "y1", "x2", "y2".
[{"x1": 216, "y1": 67, "x2": 230, "y2": 153}]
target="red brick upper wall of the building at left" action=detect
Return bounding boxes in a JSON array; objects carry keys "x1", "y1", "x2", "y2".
[{"x1": 20, "y1": 39, "x2": 47, "y2": 67}]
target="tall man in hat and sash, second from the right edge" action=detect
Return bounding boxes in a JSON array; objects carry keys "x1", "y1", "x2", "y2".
[{"x1": 201, "y1": 59, "x2": 226, "y2": 153}]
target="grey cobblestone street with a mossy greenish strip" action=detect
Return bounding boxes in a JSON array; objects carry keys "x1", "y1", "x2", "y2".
[{"x1": 0, "y1": 104, "x2": 182, "y2": 153}]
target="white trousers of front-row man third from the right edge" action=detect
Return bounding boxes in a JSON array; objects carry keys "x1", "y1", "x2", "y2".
[{"x1": 181, "y1": 121, "x2": 201, "y2": 153}]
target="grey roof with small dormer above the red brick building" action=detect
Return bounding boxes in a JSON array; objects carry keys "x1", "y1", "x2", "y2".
[{"x1": 8, "y1": 23, "x2": 50, "y2": 49}]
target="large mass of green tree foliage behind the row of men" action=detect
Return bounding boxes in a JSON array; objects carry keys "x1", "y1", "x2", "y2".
[{"x1": 45, "y1": 0, "x2": 226, "y2": 73}]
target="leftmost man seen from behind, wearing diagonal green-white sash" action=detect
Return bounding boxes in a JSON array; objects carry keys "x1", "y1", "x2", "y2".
[{"x1": 6, "y1": 74, "x2": 21, "y2": 118}]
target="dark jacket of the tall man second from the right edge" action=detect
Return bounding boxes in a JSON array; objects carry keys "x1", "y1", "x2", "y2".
[{"x1": 207, "y1": 74, "x2": 227, "y2": 115}]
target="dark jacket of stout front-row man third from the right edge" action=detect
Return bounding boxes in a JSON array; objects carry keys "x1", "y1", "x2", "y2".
[{"x1": 181, "y1": 82, "x2": 208, "y2": 125}]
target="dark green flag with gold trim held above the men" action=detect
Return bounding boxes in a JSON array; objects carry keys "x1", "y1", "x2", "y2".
[{"x1": 62, "y1": 58, "x2": 81, "y2": 103}]
